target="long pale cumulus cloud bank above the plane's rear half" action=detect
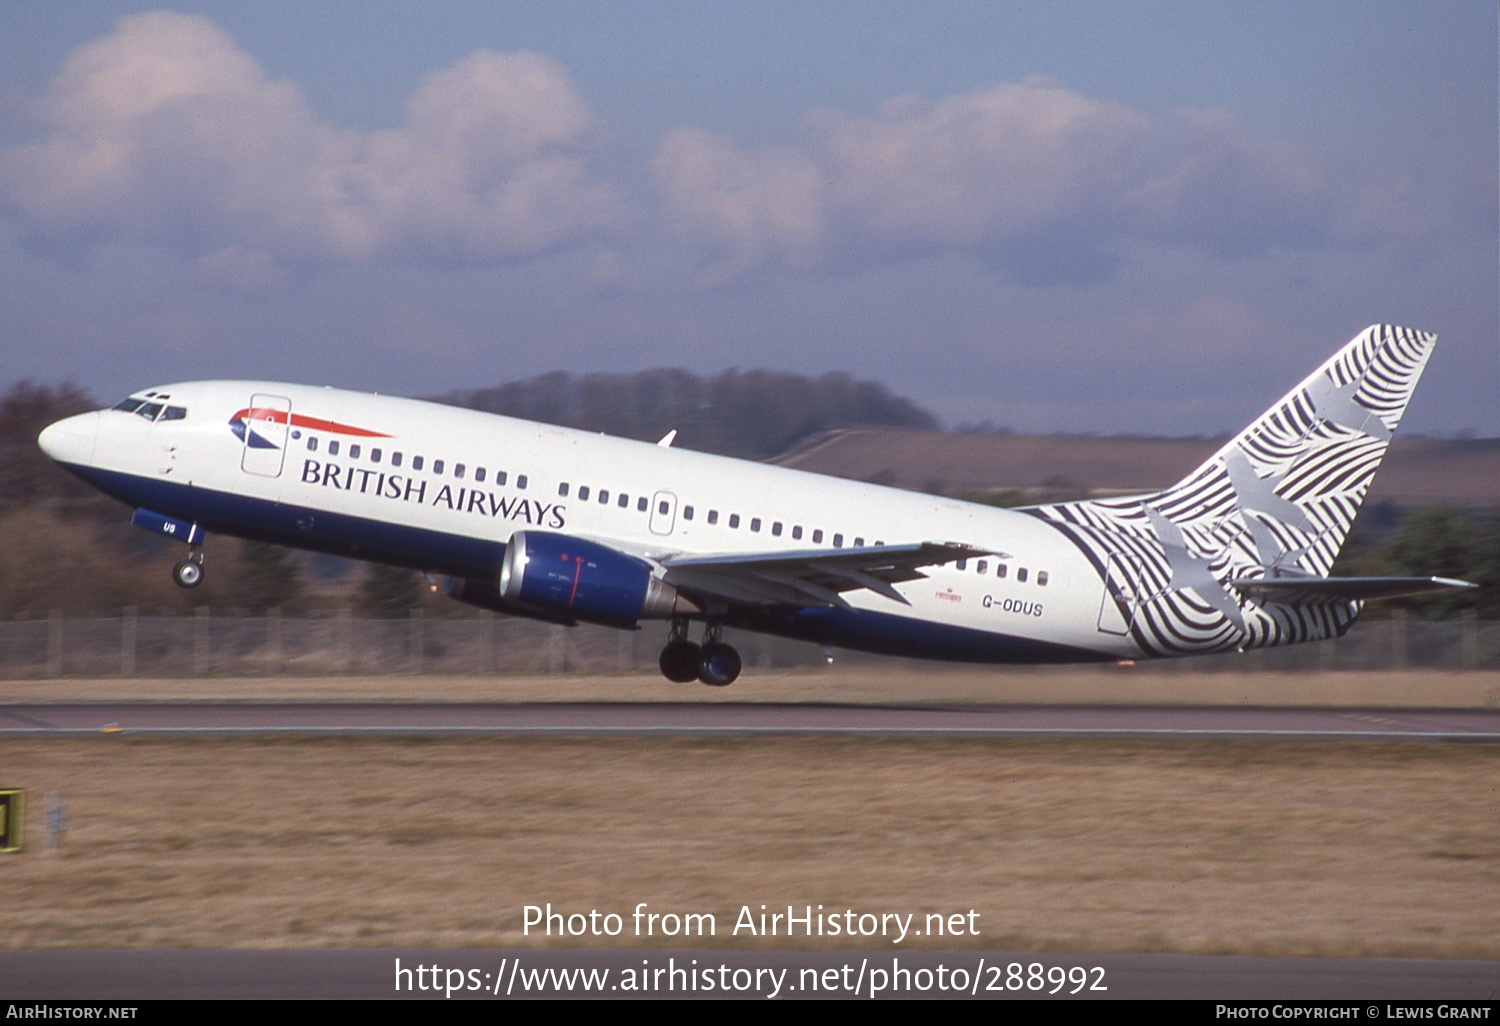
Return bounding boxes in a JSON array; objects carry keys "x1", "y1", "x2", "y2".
[{"x1": 654, "y1": 78, "x2": 1374, "y2": 285}]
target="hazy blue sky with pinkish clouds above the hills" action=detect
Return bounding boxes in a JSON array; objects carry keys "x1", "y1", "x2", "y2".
[{"x1": 0, "y1": 0, "x2": 1500, "y2": 437}]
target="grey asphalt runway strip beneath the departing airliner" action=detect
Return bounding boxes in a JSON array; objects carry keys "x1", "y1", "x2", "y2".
[{"x1": 0, "y1": 702, "x2": 1500, "y2": 743}]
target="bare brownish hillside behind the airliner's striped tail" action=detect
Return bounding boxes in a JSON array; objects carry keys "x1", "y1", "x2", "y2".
[{"x1": 773, "y1": 429, "x2": 1500, "y2": 509}]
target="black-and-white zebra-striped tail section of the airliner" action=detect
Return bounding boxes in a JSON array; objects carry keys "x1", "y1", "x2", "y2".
[{"x1": 1028, "y1": 326, "x2": 1437, "y2": 656}]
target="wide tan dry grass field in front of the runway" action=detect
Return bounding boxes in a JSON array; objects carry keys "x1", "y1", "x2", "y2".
[{"x1": 0, "y1": 737, "x2": 1500, "y2": 959}]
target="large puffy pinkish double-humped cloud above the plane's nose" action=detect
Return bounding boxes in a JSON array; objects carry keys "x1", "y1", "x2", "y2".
[{"x1": 0, "y1": 12, "x2": 624, "y2": 276}]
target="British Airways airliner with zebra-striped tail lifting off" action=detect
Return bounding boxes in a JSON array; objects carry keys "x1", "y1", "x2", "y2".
[{"x1": 39, "y1": 326, "x2": 1469, "y2": 686}]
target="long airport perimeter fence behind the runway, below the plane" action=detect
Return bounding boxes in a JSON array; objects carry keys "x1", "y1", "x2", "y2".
[{"x1": 0, "y1": 608, "x2": 1500, "y2": 680}]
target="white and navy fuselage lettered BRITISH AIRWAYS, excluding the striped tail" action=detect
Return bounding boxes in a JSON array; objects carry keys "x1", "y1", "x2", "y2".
[{"x1": 42, "y1": 381, "x2": 1142, "y2": 662}]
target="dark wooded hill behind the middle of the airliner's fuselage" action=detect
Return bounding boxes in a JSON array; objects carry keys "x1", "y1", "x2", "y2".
[{"x1": 437, "y1": 369, "x2": 938, "y2": 459}]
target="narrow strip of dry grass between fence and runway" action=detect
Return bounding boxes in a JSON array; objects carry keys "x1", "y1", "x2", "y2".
[{"x1": 0, "y1": 660, "x2": 1500, "y2": 708}]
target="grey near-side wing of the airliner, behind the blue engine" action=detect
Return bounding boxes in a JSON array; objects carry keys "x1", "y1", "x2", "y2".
[{"x1": 662, "y1": 542, "x2": 1001, "y2": 609}]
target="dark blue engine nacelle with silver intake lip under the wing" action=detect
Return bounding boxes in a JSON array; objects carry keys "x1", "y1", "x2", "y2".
[{"x1": 500, "y1": 531, "x2": 702, "y2": 627}]
